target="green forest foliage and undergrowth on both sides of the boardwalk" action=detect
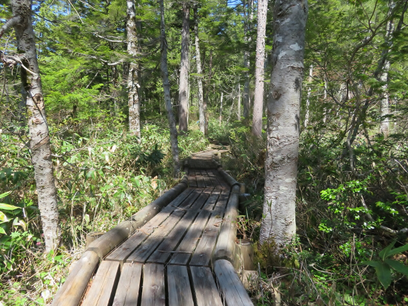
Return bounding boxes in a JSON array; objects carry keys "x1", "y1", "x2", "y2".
[{"x1": 0, "y1": 0, "x2": 408, "y2": 305}]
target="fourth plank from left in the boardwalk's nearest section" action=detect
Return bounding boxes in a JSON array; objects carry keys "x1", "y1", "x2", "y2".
[{"x1": 167, "y1": 265, "x2": 194, "y2": 306}]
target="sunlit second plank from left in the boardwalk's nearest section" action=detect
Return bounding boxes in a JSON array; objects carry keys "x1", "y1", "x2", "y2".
[{"x1": 112, "y1": 263, "x2": 143, "y2": 306}]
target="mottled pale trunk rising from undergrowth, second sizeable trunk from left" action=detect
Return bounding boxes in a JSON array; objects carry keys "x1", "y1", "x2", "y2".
[{"x1": 126, "y1": 0, "x2": 140, "y2": 138}]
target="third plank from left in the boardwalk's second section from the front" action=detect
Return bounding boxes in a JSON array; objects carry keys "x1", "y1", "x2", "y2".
[{"x1": 147, "y1": 188, "x2": 212, "y2": 263}]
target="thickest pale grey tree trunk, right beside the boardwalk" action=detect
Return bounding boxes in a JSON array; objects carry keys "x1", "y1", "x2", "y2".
[{"x1": 260, "y1": 0, "x2": 307, "y2": 249}]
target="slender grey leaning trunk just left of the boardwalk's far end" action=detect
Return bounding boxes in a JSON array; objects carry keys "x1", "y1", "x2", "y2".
[{"x1": 160, "y1": 0, "x2": 180, "y2": 176}]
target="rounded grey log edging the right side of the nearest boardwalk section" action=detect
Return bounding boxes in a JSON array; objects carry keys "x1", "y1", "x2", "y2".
[{"x1": 214, "y1": 259, "x2": 253, "y2": 306}]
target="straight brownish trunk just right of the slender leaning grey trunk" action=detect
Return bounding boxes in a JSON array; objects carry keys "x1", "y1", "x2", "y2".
[{"x1": 179, "y1": 2, "x2": 190, "y2": 132}]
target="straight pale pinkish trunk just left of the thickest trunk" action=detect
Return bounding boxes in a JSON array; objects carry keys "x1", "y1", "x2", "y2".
[{"x1": 252, "y1": 0, "x2": 268, "y2": 137}]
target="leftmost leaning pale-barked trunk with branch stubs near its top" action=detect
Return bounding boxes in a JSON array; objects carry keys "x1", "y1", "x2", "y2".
[{"x1": 0, "y1": 0, "x2": 60, "y2": 252}]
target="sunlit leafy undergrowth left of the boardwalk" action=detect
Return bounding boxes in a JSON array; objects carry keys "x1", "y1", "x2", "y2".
[{"x1": 0, "y1": 116, "x2": 208, "y2": 306}]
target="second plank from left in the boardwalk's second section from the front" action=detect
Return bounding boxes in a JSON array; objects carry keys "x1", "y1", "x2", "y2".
[{"x1": 126, "y1": 210, "x2": 185, "y2": 263}]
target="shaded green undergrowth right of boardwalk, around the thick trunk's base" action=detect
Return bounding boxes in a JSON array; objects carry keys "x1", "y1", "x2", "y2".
[{"x1": 210, "y1": 118, "x2": 408, "y2": 305}]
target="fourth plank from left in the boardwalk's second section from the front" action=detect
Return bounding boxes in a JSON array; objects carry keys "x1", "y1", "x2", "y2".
[{"x1": 170, "y1": 190, "x2": 220, "y2": 265}]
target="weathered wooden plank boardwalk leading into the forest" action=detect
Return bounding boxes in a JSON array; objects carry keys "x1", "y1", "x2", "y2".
[{"x1": 53, "y1": 152, "x2": 252, "y2": 306}]
